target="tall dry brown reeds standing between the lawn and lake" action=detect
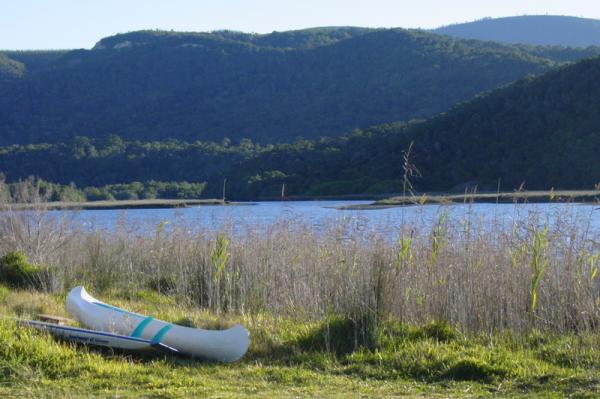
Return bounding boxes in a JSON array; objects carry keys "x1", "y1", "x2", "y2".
[{"x1": 0, "y1": 205, "x2": 600, "y2": 334}]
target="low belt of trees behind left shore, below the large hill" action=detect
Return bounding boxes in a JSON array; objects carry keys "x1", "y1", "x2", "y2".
[{"x1": 0, "y1": 135, "x2": 258, "y2": 187}]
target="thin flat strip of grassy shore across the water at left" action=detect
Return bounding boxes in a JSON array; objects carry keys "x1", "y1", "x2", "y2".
[{"x1": 0, "y1": 199, "x2": 237, "y2": 210}]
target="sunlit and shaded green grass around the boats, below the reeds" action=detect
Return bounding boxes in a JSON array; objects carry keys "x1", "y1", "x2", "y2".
[{"x1": 0, "y1": 287, "x2": 600, "y2": 398}]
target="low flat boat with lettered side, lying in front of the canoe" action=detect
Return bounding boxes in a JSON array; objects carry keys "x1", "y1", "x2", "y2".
[{"x1": 17, "y1": 320, "x2": 177, "y2": 353}]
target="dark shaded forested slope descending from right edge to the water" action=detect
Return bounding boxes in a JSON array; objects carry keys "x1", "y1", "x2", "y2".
[{"x1": 229, "y1": 54, "x2": 600, "y2": 196}]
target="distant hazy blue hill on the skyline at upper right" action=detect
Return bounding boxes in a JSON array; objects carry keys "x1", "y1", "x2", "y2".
[{"x1": 434, "y1": 15, "x2": 600, "y2": 47}]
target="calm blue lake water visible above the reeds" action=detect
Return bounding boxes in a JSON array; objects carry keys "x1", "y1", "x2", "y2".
[{"x1": 54, "y1": 201, "x2": 600, "y2": 236}]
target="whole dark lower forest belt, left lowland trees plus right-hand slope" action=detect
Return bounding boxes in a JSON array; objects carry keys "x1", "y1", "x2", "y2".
[{"x1": 0, "y1": 58, "x2": 600, "y2": 199}]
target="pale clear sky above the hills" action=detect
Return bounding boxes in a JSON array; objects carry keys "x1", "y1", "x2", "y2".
[{"x1": 0, "y1": 0, "x2": 600, "y2": 50}]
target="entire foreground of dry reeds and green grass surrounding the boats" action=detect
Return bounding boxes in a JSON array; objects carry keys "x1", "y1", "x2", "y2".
[{"x1": 0, "y1": 206, "x2": 600, "y2": 398}]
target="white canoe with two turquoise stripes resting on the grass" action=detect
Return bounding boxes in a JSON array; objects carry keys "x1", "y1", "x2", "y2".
[{"x1": 67, "y1": 287, "x2": 250, "y2": 362}]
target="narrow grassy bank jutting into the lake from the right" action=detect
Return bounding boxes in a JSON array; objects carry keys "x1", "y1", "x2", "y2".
[{"x1": 341, "y1": 190, "x2": 600, "y2": 209}]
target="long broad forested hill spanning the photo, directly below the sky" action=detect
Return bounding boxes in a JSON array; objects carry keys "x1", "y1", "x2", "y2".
[{"x1": 0, "y1": 28, "x2": 600, "y2": 145}]
